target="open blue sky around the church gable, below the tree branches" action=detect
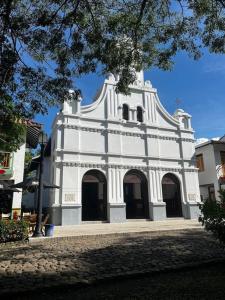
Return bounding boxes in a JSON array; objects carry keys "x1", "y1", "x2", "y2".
[{"x1": 36, "y1": 51, "x2": 225, "y2": 138}]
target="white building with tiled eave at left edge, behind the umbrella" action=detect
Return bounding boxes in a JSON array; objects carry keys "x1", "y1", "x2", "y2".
[{"x1": 0, "y1": 121, "x2": 41, "y2": 213}]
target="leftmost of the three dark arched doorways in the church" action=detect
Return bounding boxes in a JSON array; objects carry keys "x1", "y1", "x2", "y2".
[{"x1": 82, "y1": 170, "x2": 107, "y2": 221}]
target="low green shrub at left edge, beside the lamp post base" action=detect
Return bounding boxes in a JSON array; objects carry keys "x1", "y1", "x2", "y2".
[{"x1": 0, "y1": 220, "x2": 28, "y2": 243}]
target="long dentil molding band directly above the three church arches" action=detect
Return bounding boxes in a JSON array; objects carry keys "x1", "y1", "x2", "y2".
[{"x1": 55, "y1": 161, "x2": 198, "y2": 172}]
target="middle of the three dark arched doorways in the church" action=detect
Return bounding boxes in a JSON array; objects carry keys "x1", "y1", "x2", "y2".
[{"x1": 123, "y1": 170, "x2": 149, "y2": 219}]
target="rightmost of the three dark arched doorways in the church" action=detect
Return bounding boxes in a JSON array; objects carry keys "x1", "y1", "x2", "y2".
[{"x1": 162, "y1": 173, "x2": 182, "y2": 218}]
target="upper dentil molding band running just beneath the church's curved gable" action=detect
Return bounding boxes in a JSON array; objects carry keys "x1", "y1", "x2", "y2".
[{"x1": 62, "y1": 123, "x2": 195, "y2": 143}]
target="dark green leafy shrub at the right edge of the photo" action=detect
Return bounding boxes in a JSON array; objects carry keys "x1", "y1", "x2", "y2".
[{"x1": 199, "y1": 190, "x2": 225, "y2": 244}]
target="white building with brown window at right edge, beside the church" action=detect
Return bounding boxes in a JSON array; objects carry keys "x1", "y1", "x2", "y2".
[{"x1": 195, "y1": 137, "x2": 225, "y2": 199}]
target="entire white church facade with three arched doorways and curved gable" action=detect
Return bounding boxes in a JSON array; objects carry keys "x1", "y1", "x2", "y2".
[{"x1": 49, "y1": 72, "x2": 200, "y2": 225}]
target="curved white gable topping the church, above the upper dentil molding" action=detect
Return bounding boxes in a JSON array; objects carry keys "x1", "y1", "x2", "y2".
[{"x1": 65, "y1": 72, "x2": 192, "y2": 130}]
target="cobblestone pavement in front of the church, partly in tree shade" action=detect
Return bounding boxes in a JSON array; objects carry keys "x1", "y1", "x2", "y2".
[{"x1": 0, "y1": 229, "x2": 225, "y2": 294}]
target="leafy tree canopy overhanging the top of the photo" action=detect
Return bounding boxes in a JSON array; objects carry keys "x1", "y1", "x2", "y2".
[{"x1": 0, "y1": 0, "x2": 225, "y2": 150}]
